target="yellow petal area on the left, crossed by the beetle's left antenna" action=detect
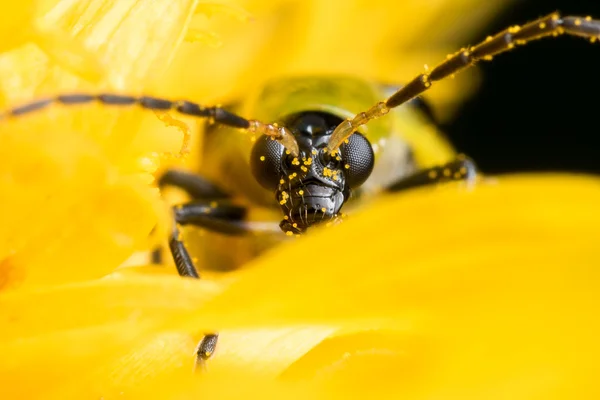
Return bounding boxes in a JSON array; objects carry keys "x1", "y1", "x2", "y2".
[{"x1": 0, "y1": 0, "x2": 206, "y2": 287}]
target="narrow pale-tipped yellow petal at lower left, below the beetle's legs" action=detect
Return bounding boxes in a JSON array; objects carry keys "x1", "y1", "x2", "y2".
[{"x1": 0, "y1": 274, "x2": 222, "y2": 341}]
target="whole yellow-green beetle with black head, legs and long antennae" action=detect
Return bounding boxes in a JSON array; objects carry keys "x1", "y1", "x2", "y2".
[{"x1": 0, "y1": 12, "x2": 600, "y2": 362}]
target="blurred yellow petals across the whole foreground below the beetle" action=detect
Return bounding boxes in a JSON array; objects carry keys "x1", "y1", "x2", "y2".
[{"x1": 0, "y1": 175, "x2": 600, "y2": 399}]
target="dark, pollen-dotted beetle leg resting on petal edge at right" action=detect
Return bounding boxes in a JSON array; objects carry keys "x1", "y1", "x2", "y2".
[{"x1": 386, "y1": 155, "x2": 477, "y2": 192}]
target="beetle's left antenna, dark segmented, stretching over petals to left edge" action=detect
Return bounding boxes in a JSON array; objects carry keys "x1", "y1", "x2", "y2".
[{"x1": 0, "y1": 93, "x2": 299, "y2": 156}]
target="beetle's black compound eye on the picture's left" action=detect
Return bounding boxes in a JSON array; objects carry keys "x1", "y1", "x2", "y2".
[{"x1": 250, "y1": 135, "x2": 285, "y2": 190}]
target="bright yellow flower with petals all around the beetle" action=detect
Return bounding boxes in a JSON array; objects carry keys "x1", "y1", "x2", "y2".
[{"x1": 5, "y1": 0, "x2": 600, "y2": 399}]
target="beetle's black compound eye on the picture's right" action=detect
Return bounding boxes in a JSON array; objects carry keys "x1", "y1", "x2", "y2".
[{"x1": 340, "y1": 133, "x2": 375, "y2": 188}]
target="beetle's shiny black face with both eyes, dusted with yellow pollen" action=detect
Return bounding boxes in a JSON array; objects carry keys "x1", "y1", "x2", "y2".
[{"x1": 251, "y1": 111, "x2": 374, "y2": 233}]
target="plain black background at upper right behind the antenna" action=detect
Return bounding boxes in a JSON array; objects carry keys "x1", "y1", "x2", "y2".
[{"x1": 443, "y1": 0, "x2": 600, "y2": 174}]
